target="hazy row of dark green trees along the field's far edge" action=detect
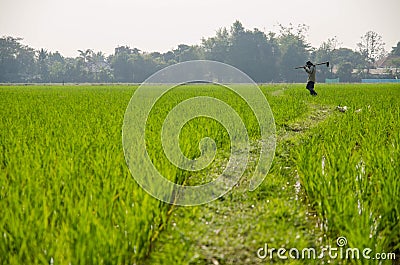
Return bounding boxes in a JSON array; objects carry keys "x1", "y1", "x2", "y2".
[{"x1": 0, "y1": 21, "x2": 400, "y2": 83}]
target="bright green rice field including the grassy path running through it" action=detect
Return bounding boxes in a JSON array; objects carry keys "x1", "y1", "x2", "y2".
[{"x1": 0, "y1": 84, "x2": 400, "y2": 265}]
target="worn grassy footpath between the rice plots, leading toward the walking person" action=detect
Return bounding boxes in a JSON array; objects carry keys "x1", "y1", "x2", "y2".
[{"x1": 146, "y1": 101, "x2": 334, "y2": 265}]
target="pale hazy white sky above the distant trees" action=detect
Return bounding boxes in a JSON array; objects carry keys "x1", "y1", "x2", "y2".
[{"x1": 0, "y1": 0, "x2": 400, "y2": 57}]
